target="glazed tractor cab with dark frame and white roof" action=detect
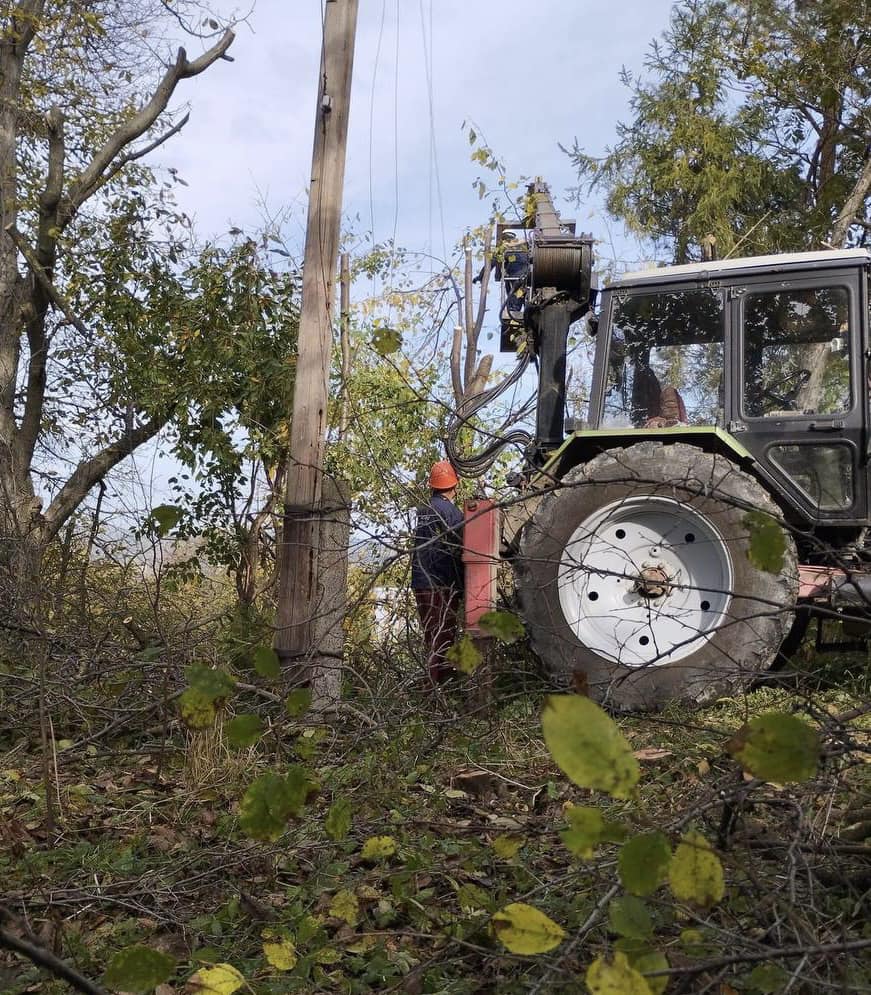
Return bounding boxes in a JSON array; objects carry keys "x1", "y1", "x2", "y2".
[{"x1": 575, "y1": 249, "x2": 871, "y2": 526}]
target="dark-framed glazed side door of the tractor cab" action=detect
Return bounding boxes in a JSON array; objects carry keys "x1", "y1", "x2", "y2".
[{"x1": 730, "y1": 269, "x2": 867, "y2": 525}]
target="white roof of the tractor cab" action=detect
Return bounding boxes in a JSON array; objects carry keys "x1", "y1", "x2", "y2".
[{"x1": 606, "y1": 249, "x2": 871, "y2": 288}]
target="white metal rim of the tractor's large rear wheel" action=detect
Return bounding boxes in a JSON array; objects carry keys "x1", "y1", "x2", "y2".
[{"x1": 558, "y1": 497, "x2": 732, "y2": 667}]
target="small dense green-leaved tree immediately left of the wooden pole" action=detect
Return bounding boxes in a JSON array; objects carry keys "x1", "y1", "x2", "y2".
[{"x1": 158, "y1": 235, "x2": 299, "y2": 609}]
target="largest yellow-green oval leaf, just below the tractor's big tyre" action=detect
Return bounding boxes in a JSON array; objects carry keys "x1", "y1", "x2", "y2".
[{"x1": 541, "y1": 694, "x2": 640, "y2": 798}]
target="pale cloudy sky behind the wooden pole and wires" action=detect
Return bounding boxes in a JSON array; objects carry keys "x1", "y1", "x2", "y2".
[{"x1": 169, "y1": 0, "x2": 671, "y2": 270}]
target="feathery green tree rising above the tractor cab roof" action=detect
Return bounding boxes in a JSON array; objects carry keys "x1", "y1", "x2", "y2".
[{"x1": 570, "y1": 0, "x2": 871, "y2": 263}]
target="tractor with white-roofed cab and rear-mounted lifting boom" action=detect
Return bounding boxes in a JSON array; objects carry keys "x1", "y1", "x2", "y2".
[{"x1": 447, "y1": 182, "x2": 871, "y2": 710}]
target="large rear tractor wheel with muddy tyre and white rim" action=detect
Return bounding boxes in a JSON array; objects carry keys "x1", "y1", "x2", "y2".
[{"x1": 516, "y1": 441, "x2": 798, "y2": 710}]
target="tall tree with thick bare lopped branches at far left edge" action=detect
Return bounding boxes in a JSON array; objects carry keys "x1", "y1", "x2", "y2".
[{"x1": 0, "y1": 0, "x2": 233, "y2": 600}]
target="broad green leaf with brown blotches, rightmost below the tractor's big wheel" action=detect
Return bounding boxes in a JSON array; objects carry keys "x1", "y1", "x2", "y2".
[{"x1": 726, "y1": 712, "x2": 820, "y2": 784}]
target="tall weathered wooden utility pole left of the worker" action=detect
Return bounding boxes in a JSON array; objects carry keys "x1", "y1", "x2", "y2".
[{"x1": 275, "y1": 0, "x2": 358, "y2": 683}]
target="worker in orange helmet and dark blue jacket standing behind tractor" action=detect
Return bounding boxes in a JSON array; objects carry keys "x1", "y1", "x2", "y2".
[{"x1": 411, "y1": 460, "x2": 463, "y2": 684}]
